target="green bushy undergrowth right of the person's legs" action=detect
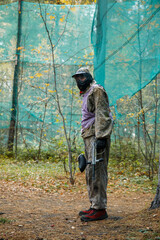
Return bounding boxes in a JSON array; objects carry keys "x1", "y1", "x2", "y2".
[{"x1": 109, "y1": 139, "x2": 159, "y2": 181}]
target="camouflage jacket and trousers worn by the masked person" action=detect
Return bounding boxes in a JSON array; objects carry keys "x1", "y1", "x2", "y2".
[{"x1": 82, "y1": 82, "x2": 112, "y2": 209}]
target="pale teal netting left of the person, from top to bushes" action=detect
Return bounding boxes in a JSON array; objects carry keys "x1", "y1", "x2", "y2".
[{"x1": 0, "y1": 1, "x2": 95, "y2": 147}]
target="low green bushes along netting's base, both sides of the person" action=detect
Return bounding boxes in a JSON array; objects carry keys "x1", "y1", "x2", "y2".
[{"x1": 0, "y1": 137, "x2": 158, "y2": 179}]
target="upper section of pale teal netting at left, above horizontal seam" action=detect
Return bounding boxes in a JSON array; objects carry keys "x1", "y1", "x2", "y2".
[{"x1": 0, "y1": 1, "x2": 95, "y2": 65}]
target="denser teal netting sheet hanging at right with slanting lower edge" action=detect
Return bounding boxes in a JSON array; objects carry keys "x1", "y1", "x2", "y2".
[{"x1": 92, "y1": 0, "x2": 160, "y2": 104}]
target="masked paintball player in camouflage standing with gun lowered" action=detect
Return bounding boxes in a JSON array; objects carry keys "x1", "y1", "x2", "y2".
[{"x1": 72, "y1": 68, "x2": 112, "y2": 222}]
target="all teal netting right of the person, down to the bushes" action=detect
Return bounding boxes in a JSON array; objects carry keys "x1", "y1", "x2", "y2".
[{"x1": 92, "y1": 0, "x2": 160, "y2": 153}]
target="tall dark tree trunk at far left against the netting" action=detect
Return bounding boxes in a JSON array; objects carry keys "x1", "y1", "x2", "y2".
[{"x1": 8, "y1": 0, "x2": 22, "y2": 152}]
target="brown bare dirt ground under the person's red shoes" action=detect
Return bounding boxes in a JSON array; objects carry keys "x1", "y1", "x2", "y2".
[{"x1": 0, "y1": 181, "x2": 160, "y2": 240}]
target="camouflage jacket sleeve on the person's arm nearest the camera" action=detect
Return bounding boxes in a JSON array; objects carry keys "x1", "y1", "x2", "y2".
[{"x1": 87, "y1": 85, "x2": 113, "y2": 138}]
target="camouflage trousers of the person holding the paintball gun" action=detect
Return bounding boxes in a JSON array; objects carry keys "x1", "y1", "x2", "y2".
[{"x1": 83, "y1": 136, "x2": 110, "y2": 209}]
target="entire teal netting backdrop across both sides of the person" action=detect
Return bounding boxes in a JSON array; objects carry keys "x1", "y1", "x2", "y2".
[{"x1": 0, "y1": 0, "x2": 160, "y2": 151}]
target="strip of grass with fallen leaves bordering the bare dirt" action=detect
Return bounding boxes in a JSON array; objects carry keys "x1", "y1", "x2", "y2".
[{"x1": 0, "y1": 158, "x2": 157, "y2": 192}]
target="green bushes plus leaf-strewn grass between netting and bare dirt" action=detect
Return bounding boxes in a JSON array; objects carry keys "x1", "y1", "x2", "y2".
[{"x1": 0, "y1": 140, "x2": 158, "y2": 191}]
